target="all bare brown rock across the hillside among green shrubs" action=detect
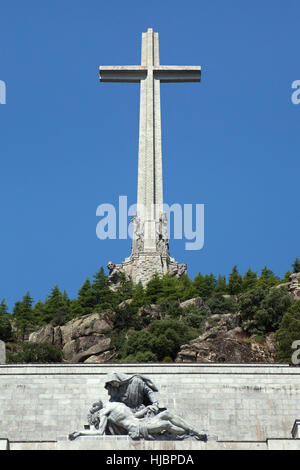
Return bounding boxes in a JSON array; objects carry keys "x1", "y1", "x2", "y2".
[{"x1": 25, "y1": 273, "x2": 300, "y2": 363}]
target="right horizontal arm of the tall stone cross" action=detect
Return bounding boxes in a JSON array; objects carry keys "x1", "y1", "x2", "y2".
[{"x1": 153, "y1": 65, "x2": 201, "y2": 83}]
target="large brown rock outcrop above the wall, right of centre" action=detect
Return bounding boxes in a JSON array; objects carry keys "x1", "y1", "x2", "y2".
[{"x1": 175, "y1": 314, "x2": 274, "y2": 363}]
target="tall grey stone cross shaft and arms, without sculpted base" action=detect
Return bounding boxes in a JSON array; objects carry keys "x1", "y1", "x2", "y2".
[{"x1": 100, "y1": 28, "x2": 201, "y2": 252}]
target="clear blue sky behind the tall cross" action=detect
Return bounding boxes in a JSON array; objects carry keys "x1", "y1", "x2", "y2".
[{"x1": 0, "y1": 0, "x2": 300, "y2": 308}]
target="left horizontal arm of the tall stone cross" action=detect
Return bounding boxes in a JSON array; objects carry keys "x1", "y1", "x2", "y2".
[{"x1": 99, "y1": 65, "x2": 147, "y2": 83}]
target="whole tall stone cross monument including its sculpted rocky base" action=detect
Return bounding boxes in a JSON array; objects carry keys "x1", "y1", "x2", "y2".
[{"x1": 100, "y1": 29, "x2": 201, "y2": 285}]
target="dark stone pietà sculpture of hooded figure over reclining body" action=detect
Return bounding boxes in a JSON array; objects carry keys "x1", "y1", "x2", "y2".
[{"x1": 69, "y1": 372, "x2": 208, "y2": 442}]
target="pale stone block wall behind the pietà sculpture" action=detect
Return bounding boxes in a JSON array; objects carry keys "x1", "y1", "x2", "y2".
[{"x1": 0, "y1": 364, "x2": 300, "y2": 445}]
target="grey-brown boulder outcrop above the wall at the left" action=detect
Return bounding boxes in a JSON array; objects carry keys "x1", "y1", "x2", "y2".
[{"x1": 29, "y1": 312, "x2": 114, "y2": 363}]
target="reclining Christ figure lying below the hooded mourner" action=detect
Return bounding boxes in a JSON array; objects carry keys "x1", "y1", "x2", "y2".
[{"x1": 69, "y1": 401, "x2": 207, "y2": 441}]
